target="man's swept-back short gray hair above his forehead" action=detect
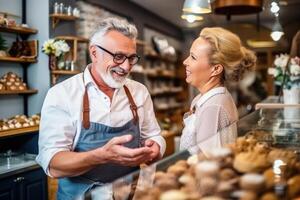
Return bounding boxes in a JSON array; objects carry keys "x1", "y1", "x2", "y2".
[{"x1": 90, "y1": 17, "x2": 138, "y2": 45}]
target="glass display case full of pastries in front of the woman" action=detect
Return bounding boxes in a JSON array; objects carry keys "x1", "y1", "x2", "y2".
[{"x1": 85, "y1": 108, "x2": 300, "y2": 200}]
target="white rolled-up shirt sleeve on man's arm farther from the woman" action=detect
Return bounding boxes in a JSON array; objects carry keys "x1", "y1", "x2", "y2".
[{"x1": 36, "y1": 88, "x2": 76, "y2": 176}]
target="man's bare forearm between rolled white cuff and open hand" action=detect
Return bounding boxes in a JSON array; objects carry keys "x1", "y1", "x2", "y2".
[{"x1": 49, "y1": 151, "x2": 102, "y2": 178}]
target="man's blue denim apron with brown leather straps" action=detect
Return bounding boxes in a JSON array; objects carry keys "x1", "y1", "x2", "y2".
[{"x1": 57, "y1": 85, "x2": 140, "y2": 200}]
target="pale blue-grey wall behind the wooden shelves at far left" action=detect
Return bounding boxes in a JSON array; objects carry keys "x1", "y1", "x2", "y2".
[{"x1": 0, "y1": 0, "x2": 50, "y2": 119}]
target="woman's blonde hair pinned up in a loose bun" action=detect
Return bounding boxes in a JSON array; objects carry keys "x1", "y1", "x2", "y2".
[{"x1": 200, "y1": 27, "x2": 256, "y2": 81}]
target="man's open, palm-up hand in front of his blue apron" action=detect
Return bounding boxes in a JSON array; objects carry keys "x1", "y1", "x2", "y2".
[{"x1": 91, "y1": 135, "x2": 154, "y2": 166}]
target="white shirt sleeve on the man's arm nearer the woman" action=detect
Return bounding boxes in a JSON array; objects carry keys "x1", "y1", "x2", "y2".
[{"x1": 141, "y1": 88, "x2": 166, "y2": 156}]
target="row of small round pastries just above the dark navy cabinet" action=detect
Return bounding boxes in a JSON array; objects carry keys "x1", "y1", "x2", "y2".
[{"x1": 0, "y1": 115, "x2": 40, "y2": 131}]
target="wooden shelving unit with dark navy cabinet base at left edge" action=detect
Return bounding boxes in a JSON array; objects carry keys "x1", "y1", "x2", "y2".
[{"x1": 0, "y1": 4, "x2": 47, "y2": 200}]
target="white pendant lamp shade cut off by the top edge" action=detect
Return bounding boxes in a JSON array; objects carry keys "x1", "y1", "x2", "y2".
[{"x1": 182, "y1": 0, "x2": 211, "y2": 14}]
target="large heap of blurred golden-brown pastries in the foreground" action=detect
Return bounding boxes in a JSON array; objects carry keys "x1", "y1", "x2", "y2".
[{"x1": 135, "y1": 136, "x2": 300, "y2": 200}]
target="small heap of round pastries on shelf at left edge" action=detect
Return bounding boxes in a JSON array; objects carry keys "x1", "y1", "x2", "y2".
[{"x1": 0, "y1": 72, "x2": 28, "y2": 91}]
